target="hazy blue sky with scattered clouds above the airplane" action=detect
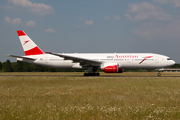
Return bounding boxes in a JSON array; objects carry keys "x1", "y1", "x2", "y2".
[{"x1": 0, "y1": 0, "x2": 180, "y2": 63}]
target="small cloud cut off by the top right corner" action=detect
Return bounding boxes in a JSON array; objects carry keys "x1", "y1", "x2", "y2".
[{"x1": 154, "y1": 0, "x2": 180, "y2": 8}]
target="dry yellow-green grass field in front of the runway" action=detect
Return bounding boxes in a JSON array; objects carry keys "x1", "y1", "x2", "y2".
[{"x1": 0, "y1": 73, "x2": 180, "y2": 120}]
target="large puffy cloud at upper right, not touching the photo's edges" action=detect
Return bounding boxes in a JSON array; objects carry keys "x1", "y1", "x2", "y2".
[{"x1": 125, "y1": 2, "x2": 172, "y2": 21}]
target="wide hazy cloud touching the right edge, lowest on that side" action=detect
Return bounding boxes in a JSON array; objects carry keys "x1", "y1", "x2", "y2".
[{"x1": 133, "y1": 18, "x2": 180, "y2": 40}]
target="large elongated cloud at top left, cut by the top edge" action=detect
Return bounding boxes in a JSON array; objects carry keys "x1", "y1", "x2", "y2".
[{"x1": 8, "y1": 0, "x2": 54, "y2": 15}]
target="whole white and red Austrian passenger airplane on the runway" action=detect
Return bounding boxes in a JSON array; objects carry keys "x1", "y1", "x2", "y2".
[{"x1": 7, "y1": 30, "x2": 175, "y2": 76}]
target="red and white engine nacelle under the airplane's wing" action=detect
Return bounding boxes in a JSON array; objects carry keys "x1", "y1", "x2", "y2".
[{"x1": 101, "y1": 63, "x2": 124, "y2": 73}]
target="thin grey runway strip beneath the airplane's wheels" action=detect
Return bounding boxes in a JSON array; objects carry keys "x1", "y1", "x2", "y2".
[{"x1": 0, "y1": 75, "x2": 180, "y2": 78}]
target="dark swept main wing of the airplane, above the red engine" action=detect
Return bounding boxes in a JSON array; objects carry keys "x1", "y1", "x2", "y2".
[{"x1": 46, "y1": 52, "x2": 102, "y2": 66}]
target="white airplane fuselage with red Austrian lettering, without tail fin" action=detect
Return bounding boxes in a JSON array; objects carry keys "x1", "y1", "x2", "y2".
[{"x1": 17, "y1": 53, "x2": 175, "y2": 69}]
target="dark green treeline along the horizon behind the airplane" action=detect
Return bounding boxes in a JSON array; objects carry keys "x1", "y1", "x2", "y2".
[{"x1": 0, "y1": 60, "x2": 180, "y2": 72}]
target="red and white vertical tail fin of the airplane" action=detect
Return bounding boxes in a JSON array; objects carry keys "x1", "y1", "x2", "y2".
[{"x1": 17, "y1": 30, "x2": 44, "y2": 56}]
